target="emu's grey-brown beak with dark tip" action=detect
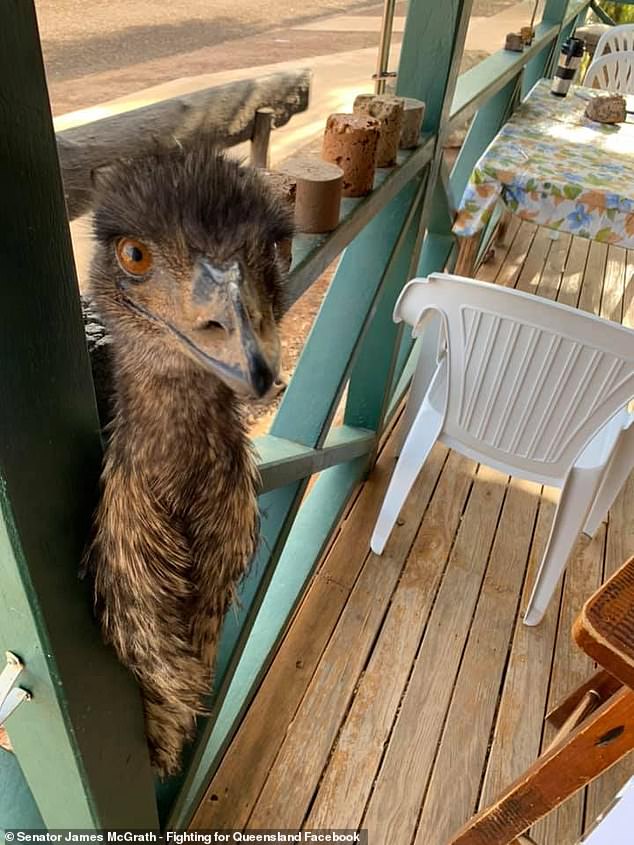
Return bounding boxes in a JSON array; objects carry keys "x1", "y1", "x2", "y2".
[{"x1": 188, "y1": 259, "x2": 279, "y2": 398}]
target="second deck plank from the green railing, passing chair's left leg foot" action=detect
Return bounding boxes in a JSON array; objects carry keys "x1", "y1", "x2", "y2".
[{"x1": 248, "y1": 450, "x2": 446, "y2": 829}]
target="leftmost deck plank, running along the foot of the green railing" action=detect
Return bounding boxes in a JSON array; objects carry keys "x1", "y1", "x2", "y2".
[{"x1": 192, "y1": 418, "x2": 440, "y2": 829}]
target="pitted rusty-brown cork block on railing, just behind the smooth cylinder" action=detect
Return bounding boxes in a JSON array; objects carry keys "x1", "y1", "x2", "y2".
[{"x1": 321, "y1": 114, "x2": 381, "y2": 197}]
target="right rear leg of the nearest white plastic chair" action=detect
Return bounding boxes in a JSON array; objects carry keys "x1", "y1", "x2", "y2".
[{"x1": 524, "y1": 467, "x2": 600, "y2": 625}]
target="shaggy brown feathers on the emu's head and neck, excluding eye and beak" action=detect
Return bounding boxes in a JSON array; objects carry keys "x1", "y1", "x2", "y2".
[{"x1": 86, "y1": 147, "x2": 291, "y2": 775}]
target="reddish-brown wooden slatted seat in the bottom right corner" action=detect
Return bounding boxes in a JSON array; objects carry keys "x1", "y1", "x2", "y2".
[{"x1": 451, "y1": 557, "x2": 634, "y2": 845}]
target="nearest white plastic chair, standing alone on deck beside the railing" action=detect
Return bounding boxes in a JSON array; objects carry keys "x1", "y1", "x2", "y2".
[{"x1": 370, "y1": 273, "x2": 634, "y2": 625}]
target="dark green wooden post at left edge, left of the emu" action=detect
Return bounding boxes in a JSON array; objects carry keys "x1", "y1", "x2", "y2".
[{"x1": 0, "y1": 0, "x2": 156, "y2": 827}]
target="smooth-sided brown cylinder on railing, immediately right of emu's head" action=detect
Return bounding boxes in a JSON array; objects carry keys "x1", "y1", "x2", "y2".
[{"x1": 282, "y1": 156, "x2": 343, "y2": 234}]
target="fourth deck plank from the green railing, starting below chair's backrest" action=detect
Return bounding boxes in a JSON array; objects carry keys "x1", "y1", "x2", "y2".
[{"x1": 362, "y1": 466, "x2": 507, "y2": 842}]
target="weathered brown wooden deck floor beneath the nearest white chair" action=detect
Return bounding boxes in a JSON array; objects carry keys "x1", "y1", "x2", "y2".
[{"x1": 193, "y1": 220, "x2": 634, "y2": 845}]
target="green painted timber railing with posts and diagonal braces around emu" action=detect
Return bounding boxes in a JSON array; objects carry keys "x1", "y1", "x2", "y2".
[{"x1": 0, "y1": 0, "x2": 590, "y2": 827}]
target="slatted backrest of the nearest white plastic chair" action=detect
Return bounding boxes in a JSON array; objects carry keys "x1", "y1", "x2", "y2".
[{"x1": 394, "y1": 273, "x2": 634, "y2": 481}]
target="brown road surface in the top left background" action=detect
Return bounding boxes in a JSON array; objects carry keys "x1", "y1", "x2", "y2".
[{"x1": 36, "y1": 0, "x2": 377, "y2": 82}]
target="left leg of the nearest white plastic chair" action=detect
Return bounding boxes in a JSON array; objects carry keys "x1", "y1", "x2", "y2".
[{"x1": 370, "y1": 358, "x2": 447, "y2": 555}]
